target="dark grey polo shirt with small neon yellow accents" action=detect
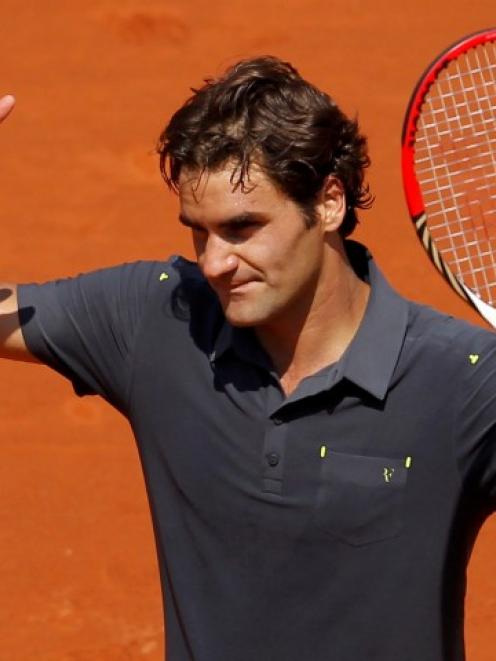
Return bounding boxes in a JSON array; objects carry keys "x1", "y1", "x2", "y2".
[{"x1": 19, "y1": 243, "x2": 496, "y2": 661}]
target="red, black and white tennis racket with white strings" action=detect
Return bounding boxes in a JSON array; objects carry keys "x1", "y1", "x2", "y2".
[{"x1": 402, "y1": 28, "x2": 496, "y2": 328}]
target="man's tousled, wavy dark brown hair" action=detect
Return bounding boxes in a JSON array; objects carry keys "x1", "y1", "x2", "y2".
[{"x1": 157, "y1": 57, "x2": 373, "y2": 237}]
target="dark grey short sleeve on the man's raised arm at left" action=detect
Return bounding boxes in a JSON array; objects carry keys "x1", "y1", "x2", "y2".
[{"x1": 18, "y1": 262, "x2": 167, "y2": 412}]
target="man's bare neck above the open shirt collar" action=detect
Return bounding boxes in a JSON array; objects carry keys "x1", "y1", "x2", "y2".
[{"x1": 256, "y1": 244, "x2": 370, "y2": 395}]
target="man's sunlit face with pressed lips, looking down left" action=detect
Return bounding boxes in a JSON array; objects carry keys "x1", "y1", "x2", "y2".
[{"x1": 179, "y1": 166, "x2": 330, "y2": 327}]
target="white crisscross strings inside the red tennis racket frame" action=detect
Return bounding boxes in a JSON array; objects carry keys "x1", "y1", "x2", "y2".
[{"x1": 415, "y1": 42, "x2": 496, "y2": 304}]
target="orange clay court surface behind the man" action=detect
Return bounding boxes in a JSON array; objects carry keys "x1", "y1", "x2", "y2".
[{"x1": 0, "y1": 0, "x2": 496, "y2": 661}]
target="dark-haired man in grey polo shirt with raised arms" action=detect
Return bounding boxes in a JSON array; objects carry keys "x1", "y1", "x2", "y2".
[{"x1": 0, "y1": 58, "x2": 496, "y2": 661}]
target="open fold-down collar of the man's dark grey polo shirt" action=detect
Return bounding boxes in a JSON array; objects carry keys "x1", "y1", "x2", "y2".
[{"x1": 210, "y1": 240, "x2": 408, "y2": 400}]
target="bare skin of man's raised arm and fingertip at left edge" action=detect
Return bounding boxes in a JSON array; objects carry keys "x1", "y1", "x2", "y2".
[{"x1": 0, "y1": 95, "x2": 37, "y2": 362}]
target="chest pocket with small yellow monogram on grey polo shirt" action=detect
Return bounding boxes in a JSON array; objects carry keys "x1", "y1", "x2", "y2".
[{"x1": 315, "y1": 450, "x2": 408, "y2": 546}]
